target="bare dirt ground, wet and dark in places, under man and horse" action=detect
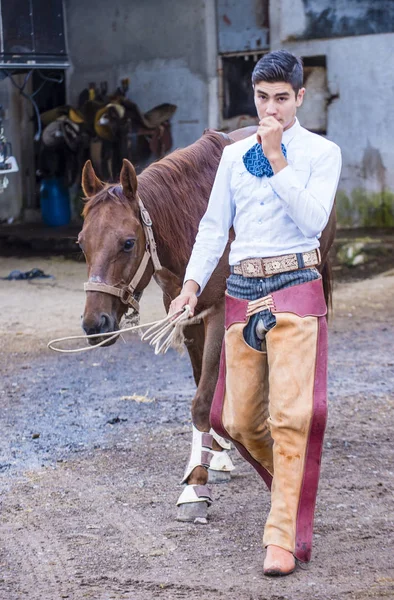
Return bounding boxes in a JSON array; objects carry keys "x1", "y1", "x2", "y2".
[{"x1": 0, "y1": 257, "x2": 394, "y2": 600}]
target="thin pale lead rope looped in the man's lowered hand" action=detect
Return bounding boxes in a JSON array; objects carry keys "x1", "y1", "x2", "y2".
[{"x1": 47, "y1": 305, "x2": 190, "y2": 354}]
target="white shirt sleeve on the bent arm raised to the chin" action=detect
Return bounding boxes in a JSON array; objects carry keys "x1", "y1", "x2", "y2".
[{"x1": 269, "y1": 144, "x2": 342, "y2": 238}]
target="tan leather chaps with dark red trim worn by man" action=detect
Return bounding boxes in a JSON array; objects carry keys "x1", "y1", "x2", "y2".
[{"x1": 211, "y1": 279, "x2": 327, "y2": 562}]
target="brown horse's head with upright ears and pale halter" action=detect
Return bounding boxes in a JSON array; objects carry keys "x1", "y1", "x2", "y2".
[{"x1": 78, "y1": 160, "x2": 153, "y2": 344}]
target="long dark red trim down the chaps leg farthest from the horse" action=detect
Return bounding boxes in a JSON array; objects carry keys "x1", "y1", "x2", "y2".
[{"x1": 294, "y1": 317, "x2": 327, "y2": 562}]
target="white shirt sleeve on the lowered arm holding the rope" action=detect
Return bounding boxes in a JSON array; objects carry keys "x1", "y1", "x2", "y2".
[{"x1": 184, "y1": 148, "x2": 234, "y2": 295}]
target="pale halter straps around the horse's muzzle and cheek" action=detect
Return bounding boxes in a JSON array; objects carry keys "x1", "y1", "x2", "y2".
[{"x1": 83, "y1": 193, "x2": 162, "y2": 313}]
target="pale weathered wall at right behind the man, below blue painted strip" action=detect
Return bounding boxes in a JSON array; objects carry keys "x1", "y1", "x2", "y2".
[{"x1": 270, "y1": 0, "x2": 394, "y2": 225}]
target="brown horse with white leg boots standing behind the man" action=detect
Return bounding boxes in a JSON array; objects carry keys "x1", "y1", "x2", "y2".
[{"x1": 79, "y1": 128, "x2": 336, "y2": 520}]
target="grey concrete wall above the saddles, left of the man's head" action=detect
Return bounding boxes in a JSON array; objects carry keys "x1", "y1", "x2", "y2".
[{"x1": 65, "y1": 0, "x2": 218, "y2": 147}]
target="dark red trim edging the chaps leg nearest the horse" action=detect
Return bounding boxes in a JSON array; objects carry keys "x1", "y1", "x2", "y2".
[{"x1": 210, "y1": 340, "x2": 272, "y2": 490}]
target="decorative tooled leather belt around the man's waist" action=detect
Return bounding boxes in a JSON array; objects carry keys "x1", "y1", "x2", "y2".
[{"x1": 231, "y1": 248, "x2": 321, "y2": 277}]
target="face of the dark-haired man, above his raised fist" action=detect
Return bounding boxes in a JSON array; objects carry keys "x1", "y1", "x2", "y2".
[{"x1": 254, "y1": 81, "x2": 305, "y2": 130}]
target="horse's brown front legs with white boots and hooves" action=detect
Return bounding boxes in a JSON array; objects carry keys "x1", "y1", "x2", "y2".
[{"x1": 177, "y1": 309, "x2": 234, "y2": 521}]
